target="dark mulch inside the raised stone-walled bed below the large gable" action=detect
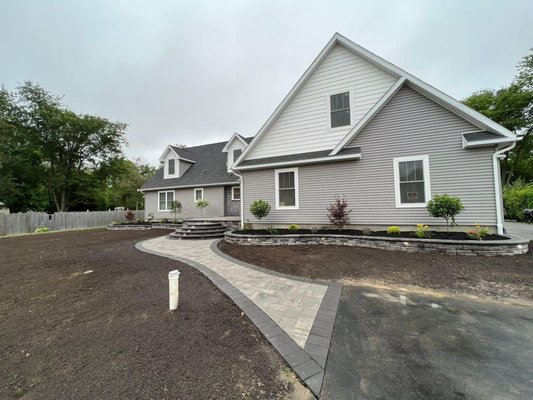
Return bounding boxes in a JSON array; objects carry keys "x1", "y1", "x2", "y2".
[{"x1": 233, "y1": 229, "x2": 509, "y2": 241}]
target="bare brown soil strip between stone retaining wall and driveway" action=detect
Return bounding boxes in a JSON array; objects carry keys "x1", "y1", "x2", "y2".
[{"x1": 219, "y1": 241, "x2": 533, "y2": 299}]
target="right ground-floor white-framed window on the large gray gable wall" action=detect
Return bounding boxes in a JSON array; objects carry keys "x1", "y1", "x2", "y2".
[{"x1": 393, "y1": 155, "x2": 431, "y2": 207}]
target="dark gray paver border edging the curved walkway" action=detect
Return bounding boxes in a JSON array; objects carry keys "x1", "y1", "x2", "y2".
[{"x1": 135, "y1": 238, "x2": 342, "y2": 397}]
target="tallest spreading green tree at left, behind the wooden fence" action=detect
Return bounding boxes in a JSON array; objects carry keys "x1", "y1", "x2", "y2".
[{"x1": 0, "y1": 82, "x2": 126, "y2": 211}]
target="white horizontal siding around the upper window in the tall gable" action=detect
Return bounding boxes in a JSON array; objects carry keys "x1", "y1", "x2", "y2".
[{"x1": 247, "y1": 45, "x2": 396, "y2": 159}]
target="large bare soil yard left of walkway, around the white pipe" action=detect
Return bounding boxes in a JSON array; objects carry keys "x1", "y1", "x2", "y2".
[{"x1": 0, "y1": 230, "x2": 303, "y2": 400}]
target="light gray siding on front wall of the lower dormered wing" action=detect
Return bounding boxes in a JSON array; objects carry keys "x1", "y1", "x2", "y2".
[{"x1": 144, "y1": 186, "x2": 224, "y2": 219}]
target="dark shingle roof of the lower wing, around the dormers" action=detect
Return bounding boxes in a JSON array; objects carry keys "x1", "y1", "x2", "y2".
[{"x1": 141, "y1": 138, "x2": 241, "y2": 190}]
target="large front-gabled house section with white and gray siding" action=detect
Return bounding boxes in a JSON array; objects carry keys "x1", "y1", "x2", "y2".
[{"x1": 233, "y1": 34, "x2": 517, "y2": 233}]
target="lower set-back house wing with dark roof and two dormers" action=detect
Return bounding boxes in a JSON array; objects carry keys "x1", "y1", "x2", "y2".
[{"x1": 140, "y1": 133, "x2": 251, "y2": 220}]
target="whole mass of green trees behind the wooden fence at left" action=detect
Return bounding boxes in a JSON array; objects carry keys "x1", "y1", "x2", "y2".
[{"x1": 0, "y1": 82, "x2": 153, "y2": 212}]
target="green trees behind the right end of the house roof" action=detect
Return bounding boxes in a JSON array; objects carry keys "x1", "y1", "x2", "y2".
[{"x1": 463, "y1": 48, "x2": 533, "y2": 184}]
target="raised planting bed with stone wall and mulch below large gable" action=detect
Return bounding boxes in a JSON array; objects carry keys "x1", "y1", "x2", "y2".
[{"x1": 224, "y1": 229, "x2": 528, "y2": 256}]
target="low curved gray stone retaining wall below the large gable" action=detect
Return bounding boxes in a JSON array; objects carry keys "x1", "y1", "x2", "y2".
[{"x1": 224, "y1": 232, "x2": 528, "y2": 256}]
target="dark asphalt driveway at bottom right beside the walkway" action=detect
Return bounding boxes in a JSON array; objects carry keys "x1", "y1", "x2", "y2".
[{"x1": 321, "y1": 286, "x2": 533, "y2": 400}]
